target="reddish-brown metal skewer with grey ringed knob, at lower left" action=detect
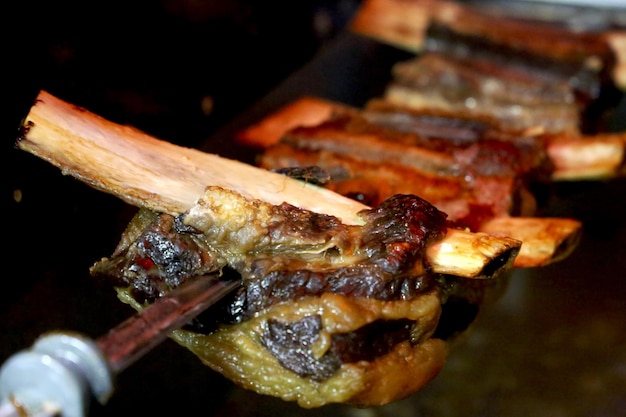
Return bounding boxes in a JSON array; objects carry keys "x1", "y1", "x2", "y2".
[{"x1": 0, "y1": 275, "x2": 241, "y2": 417}]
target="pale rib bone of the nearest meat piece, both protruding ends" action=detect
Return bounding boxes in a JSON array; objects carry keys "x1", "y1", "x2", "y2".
[{"x1": 17, "y1": 91, "x2": 521, "y2": 278}]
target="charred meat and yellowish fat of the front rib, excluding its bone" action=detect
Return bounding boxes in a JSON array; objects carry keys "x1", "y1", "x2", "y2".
[{"x1": 91, "y1": 189, "x2": 492, "y2": 407}]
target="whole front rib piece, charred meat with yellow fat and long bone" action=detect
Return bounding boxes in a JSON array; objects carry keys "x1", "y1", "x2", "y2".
[{"x1": 18, "y1": 92, "x2": 521, "y2": 407}]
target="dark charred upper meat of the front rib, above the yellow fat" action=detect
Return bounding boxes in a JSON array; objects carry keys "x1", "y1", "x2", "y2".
[{"x1": 91, "y1": 195, "x2": 447, "y2": 322}]
